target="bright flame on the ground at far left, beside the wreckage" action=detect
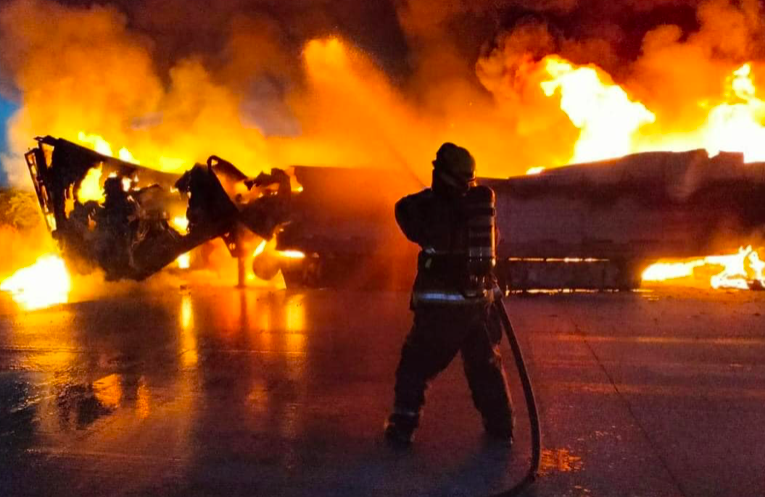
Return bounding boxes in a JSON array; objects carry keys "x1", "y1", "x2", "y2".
[{"x1": 0, "y1": 255, "x2": 72, "y2": 310}]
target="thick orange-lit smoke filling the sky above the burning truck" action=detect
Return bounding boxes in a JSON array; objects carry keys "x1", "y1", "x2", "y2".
[{"x1": 0, "y1": 0, "x2": 765, "y2": 185}]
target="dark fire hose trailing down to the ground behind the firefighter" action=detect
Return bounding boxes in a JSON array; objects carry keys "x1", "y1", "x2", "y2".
[{"x1": 494, "y1": 298, "x2": 542, "y2": 497}]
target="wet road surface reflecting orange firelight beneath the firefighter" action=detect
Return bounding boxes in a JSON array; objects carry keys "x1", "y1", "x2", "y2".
[{"x1": 0, "y1": 286, "x2": 765, "y2": 496}]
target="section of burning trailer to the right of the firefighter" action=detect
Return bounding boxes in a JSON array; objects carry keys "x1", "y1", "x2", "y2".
[{"x1": 483, "y1": 150, "x2": 765, "y2": 289}]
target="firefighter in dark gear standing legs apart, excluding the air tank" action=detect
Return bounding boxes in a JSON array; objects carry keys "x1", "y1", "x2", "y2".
[{"x1": 385, "y1": 143, "x2": 513, "y2": 447}]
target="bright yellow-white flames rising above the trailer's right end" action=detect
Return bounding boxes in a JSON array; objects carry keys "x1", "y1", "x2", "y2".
[{"x1": 540, "y1": 56, "x2": 765, "y2": 165}]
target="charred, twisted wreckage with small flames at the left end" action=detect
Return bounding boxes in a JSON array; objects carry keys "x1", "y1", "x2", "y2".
[{"x1": 18, "y1": 137, "x2": 291, "y2": 286}]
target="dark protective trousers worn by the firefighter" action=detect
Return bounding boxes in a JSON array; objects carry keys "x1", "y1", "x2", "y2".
[{"x1": 394, "y1": 305, "x2": 513, "y2": 436}]
